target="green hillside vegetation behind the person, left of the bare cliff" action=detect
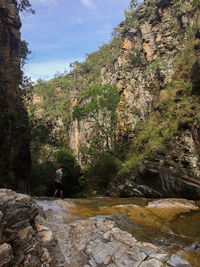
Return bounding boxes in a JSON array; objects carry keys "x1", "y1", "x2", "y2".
[{"x1": 27, "y1": 25, "x2": 123, "y2": 196}]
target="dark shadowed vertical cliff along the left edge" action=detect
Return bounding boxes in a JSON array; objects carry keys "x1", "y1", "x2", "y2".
[{"x1": 0, "y1": 0, "x2": 30, "y2": 192}]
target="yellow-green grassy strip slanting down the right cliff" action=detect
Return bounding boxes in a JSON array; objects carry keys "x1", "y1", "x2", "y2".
[{"x1": 121, "y1": 19, "x2": 200, "y2": 172}]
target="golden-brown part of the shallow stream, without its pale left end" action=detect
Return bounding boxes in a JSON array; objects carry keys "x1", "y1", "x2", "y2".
[{"x1": 66, "y1": 198, "x2": 200, "y2": 244}]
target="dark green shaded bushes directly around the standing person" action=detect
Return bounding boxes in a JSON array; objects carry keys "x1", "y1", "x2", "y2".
[{"x1": 31, "y1": 146, "x2": 81, "y2": 197}]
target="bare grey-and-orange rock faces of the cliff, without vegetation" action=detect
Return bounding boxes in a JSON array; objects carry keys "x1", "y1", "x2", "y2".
[{"x1": 69, "y1": 0, "x2": 196, "y2": 159}]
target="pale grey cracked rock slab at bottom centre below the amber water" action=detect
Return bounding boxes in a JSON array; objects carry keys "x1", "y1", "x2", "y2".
[{"x1": 56, "y1": 218, "x2": 169, "y2": 266}]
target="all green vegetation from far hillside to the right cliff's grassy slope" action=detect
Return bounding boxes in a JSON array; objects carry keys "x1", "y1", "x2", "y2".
[{"x1": 26, "y1": 0, "x2": 200, "y2": 195}]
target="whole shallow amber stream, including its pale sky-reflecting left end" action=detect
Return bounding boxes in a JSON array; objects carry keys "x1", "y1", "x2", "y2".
[{"x1": 37, "y1": 198, "x2": 200, "y2": 267}]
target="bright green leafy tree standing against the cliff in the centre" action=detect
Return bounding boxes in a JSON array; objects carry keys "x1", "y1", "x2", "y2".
[{"x1": 72, "y1": 84, "x2": 120, "y2": 155}]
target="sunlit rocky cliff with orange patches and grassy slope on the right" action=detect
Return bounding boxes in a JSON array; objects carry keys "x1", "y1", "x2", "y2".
[{"x1": 70, "y1": 0, "x2": 200, "y2": 198}]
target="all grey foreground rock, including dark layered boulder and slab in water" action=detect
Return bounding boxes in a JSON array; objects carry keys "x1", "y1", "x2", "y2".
[{"x1": 0, "y1": 189, "x2": 199, "y2": 267}]
